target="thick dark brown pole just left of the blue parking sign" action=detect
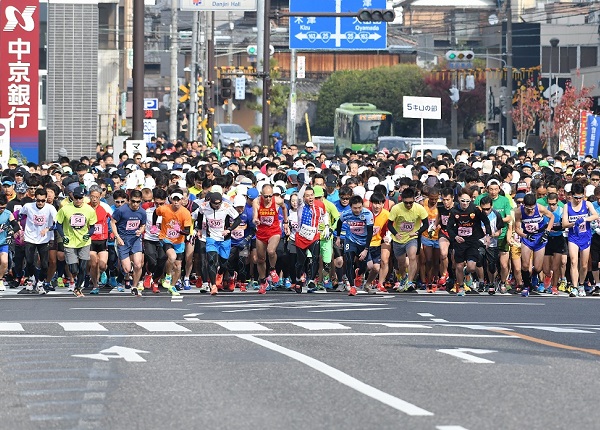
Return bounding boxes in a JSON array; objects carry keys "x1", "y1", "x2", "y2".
[{"x1": 131, "y1": 0, "x2": 145, "y2": 140}]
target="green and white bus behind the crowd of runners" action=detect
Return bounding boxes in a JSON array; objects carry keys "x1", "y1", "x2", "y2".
[{"x1": 333, "y1": 103, "x2": 394, "y2": 156}]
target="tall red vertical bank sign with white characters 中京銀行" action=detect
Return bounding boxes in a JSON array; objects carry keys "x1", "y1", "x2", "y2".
[{"x1": 0, "y1": 0, "x2": 40, "y2": 163}]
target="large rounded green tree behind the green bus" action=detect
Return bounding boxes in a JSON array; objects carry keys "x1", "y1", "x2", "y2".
[{"x1": 314, "y1": 64, "x2": 426, "y2": 136}]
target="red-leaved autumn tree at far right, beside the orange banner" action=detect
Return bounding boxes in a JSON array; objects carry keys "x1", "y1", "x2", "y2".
[{"x1": 551, "y1": 81, "x2": 593, "y2": 154}]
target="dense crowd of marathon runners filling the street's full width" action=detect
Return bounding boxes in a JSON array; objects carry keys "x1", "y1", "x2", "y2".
[{"x1": 0, "y1": 136, "x2": 600, "y2": 297}]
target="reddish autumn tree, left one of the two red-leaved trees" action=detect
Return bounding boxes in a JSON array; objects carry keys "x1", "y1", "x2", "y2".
[{"x1": 512, "y1": 80, "x2": 550, "y2": 142}]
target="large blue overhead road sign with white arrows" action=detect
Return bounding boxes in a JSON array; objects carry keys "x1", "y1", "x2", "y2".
[{"x1": 290, "y1": 0, "x2": 387, "y2": 51}]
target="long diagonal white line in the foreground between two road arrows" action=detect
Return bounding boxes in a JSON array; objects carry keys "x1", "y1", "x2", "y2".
[{"x1": 238, "y1": 334, "x2": 433, "y2": 416}]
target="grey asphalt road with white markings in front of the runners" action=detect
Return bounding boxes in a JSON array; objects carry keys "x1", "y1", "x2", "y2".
[{"x1": 0, "y1": 291, "x2": 600, "y2": 430}]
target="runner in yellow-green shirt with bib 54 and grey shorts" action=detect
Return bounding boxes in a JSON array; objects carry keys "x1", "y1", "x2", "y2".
[{"x1": 56, "y1": 187, "x2": 98, "y2": 297}]
